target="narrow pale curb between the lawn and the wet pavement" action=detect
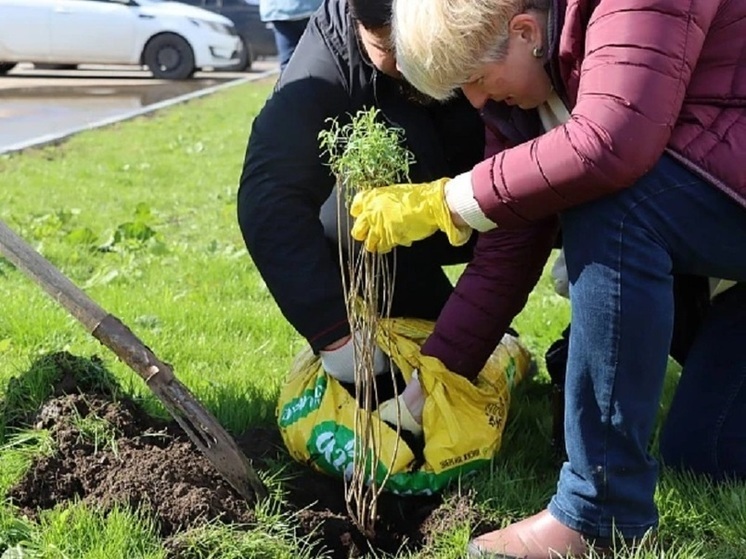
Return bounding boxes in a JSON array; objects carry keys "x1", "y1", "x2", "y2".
[{"x1": 0, "y1": 70, "x2": 279, "y2": 155}]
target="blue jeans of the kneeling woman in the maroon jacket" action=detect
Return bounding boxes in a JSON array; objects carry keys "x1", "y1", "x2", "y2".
[{"x1": 549, "y1": 155, "x2": 746, "y2": 538}]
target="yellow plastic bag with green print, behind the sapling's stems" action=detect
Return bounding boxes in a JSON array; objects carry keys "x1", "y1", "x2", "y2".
[{"x1": 277, "y1": 318, "x2": 532, "y2": 494}]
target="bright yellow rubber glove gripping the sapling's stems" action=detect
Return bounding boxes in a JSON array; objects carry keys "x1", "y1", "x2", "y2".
[{"x1": 350, "y1": 178, "x2": 471, "y2": 253}]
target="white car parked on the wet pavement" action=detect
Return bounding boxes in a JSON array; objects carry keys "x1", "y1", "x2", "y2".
[{"x1": 0, "y1": 0, "x2": 241, "y2": 80}]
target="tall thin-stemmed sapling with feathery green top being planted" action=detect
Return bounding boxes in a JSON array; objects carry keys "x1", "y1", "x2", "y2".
[{"x1": 319, "y1": 108, "x2": 414, "y2": 536}]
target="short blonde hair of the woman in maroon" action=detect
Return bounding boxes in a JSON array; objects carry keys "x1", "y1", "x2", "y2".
[{"x1": 392, "y1": 0, "x2": 536, "y2": 99}]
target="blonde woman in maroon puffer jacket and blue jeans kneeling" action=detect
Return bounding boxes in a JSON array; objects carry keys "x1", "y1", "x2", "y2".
[{"x1": 353, "y1": 0, "x2": 746, "y2": 559}]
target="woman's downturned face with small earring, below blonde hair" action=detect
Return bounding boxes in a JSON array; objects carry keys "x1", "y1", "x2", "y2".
[{"x1": 461, "y1": 12, "x2": 552, "y2": 109}]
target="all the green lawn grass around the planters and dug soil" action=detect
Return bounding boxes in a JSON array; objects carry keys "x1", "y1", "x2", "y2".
[{"x1": 0, "y1": 79, "x2": 746, "y2": 559}]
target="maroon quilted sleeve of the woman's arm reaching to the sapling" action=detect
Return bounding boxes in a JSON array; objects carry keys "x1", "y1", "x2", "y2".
[{"x1": 472, "y1": 0, "x2": 720, "y2": 228}]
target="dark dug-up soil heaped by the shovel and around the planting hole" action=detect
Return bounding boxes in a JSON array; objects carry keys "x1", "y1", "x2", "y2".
[{"x1": 4, "y1": 353, "x2": 488, "y2": 558}]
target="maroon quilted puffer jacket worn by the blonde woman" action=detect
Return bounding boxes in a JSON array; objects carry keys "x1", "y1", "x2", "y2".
[{"x1": 472, "y1": 0, "x2": 746, "y2": 228}]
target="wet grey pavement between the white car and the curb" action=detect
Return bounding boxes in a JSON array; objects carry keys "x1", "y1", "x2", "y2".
[{"x1": 0, "y1": 60, "x2": 277, "y2": 153}]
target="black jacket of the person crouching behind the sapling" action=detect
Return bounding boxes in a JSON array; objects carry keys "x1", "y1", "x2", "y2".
[{"x1": 238, "y1": 0, "x2": 484, "y2": 350}]
